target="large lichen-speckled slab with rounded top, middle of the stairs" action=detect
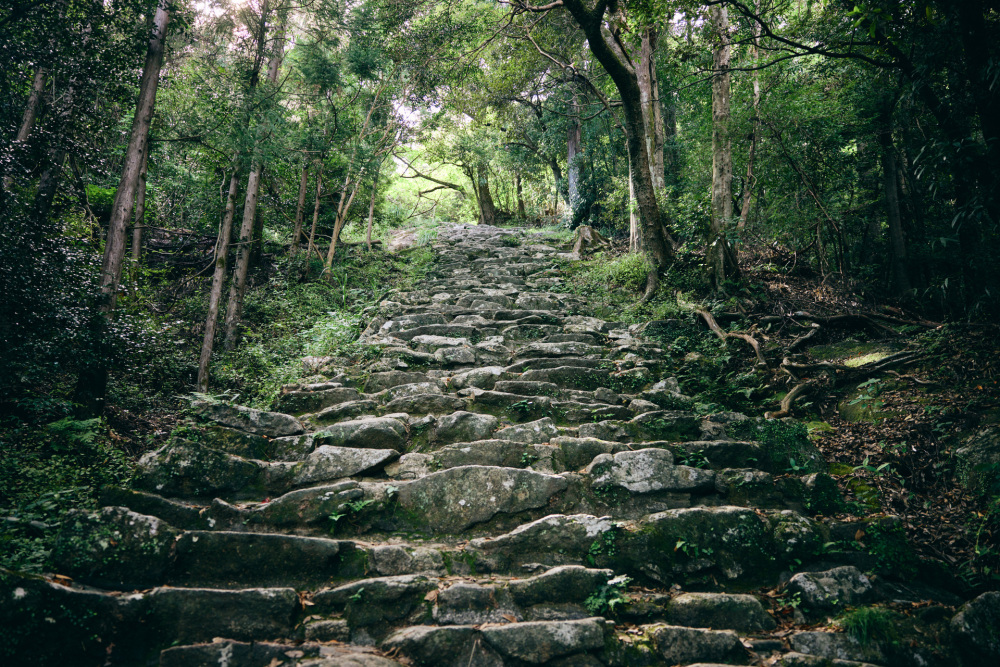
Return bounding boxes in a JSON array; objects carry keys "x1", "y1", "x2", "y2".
[{"x1": 399, "y1": 466, "x2": 568, "y2": 533}]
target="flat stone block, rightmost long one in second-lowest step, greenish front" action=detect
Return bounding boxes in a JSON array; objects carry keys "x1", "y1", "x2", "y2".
[{"x1": 666, "y1": 593, "x2": 776, "y2": 634}]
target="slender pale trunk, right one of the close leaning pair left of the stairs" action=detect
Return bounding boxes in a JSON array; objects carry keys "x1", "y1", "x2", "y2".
[{"x1": 225, "y1": 11, "x2": 283, "y2": 350}]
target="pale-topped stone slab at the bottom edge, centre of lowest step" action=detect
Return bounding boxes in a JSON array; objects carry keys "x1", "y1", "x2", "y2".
[{"x1": 481, "y1": 618, "x2": 604, "y2": 665}]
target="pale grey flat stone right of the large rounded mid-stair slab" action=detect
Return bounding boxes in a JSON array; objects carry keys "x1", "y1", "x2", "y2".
[{"x1": 587, "y1": 449, "x2": 715, "y2": 493}]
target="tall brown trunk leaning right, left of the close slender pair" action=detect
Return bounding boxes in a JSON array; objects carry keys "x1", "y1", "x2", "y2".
[{"x1": 101, "y1": 0, "x2": 170, "y2": 314}]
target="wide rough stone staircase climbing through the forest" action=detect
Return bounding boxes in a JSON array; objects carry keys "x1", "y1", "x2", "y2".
[{"x1": 0, "y1": 226, "x2": 974, "y2": 667}]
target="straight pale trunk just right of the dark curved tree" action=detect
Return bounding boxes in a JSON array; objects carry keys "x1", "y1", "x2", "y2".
[{"x1": 705, "y1": 5, "x2": 739, "y2": 289}]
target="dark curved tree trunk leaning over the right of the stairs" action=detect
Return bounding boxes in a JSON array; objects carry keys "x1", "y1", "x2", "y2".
[{"x1": 563, "y1": 0, "x2": 673, "y2": 300}]
